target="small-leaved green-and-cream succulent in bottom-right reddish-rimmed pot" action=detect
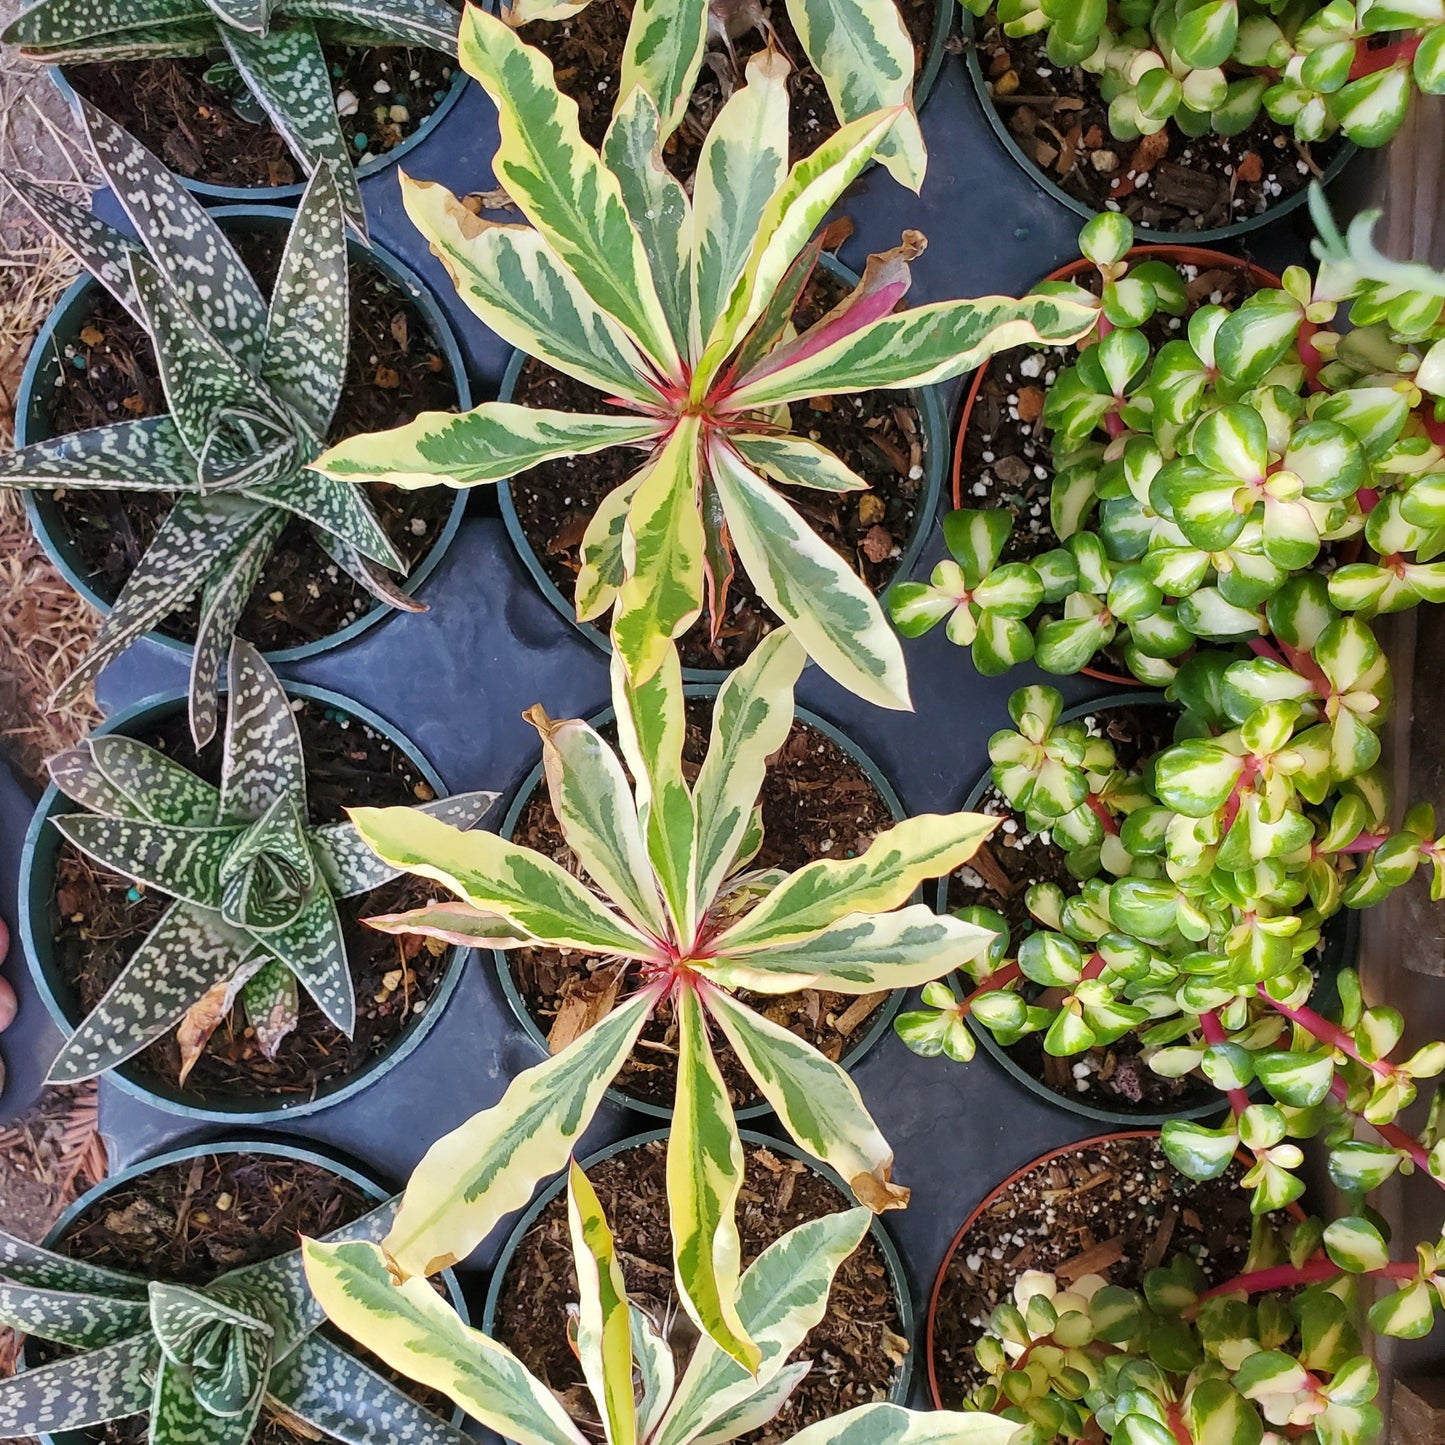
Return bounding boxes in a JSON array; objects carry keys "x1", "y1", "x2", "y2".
[{"x1": 971, "y1": 1217, "x2": 1441, "y2": 1445}]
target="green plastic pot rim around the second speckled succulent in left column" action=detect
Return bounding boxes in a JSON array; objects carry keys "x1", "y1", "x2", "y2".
[{"x1": 14, "y1": 205, "x2": 471, "y2": 663}]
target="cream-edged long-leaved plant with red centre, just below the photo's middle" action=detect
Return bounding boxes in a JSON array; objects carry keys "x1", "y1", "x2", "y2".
[{"x1": 343, "y1": 629, "x2": 994, "y2": 1370}]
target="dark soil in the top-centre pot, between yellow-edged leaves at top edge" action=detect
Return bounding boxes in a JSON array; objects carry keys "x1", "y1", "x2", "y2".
[{"x1": 517, "y1": 0, "x2": 938, "y2": 178}]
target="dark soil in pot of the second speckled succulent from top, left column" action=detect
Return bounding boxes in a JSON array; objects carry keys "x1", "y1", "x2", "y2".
[{"x1": 48, "y1": 223, "x2": 457, "y2": 650}]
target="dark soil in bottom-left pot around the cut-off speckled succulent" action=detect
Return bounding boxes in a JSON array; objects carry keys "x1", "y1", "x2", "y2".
[{"x1": 36, "y1": 1153, "x2": 451, "y2": 1445}]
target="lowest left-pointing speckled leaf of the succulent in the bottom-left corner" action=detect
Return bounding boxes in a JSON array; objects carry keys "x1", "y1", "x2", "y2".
[{"x1": 0, "y1": 1334, "x2": 160, "y2": 1436}]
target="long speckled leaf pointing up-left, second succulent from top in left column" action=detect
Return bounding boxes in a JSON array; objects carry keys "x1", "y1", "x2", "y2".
[{"x1": 78, "y1": 98, "x2": 266, "y2": 366}]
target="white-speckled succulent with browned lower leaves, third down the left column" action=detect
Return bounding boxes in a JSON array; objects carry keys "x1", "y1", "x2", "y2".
[{"x1": 51, "y1": 639, "x2": 497, "y2": 1082}]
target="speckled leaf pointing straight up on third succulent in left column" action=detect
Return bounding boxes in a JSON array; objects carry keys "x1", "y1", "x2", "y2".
[{"x1": 221, "y1": 637, "x2": 306, "y2": 822}]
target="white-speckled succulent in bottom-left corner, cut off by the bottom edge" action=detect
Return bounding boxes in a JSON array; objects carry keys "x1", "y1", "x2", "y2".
[{"x1": 0, "y1": 1199, "x2": 467, "y2": 1445}]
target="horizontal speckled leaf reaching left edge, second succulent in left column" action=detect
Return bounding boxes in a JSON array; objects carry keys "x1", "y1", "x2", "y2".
[{"x1": 0, "y1": 416, "x2": 197, "y2": 491}]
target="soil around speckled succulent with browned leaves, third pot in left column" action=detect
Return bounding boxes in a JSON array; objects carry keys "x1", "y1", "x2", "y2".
[{"x1": 49, "y1": 695, "x2": 447, "y2": 1104}]
